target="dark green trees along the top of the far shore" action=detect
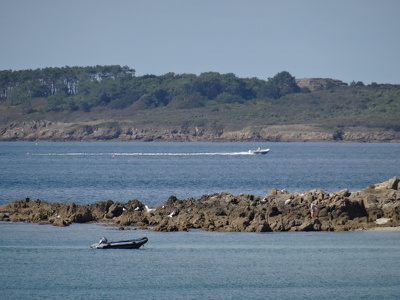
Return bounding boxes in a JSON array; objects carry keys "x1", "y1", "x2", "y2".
[{"x1": 0, "y1": 65, "x2": 304, "y2": 111}]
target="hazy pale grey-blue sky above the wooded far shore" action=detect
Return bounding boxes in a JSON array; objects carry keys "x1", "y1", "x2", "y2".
[{"x1": 0, "y1": 0, "x2": 400, "y2": 84}]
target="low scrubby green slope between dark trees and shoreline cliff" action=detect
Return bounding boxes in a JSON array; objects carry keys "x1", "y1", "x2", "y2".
[{"x1": 0, "y1": 86, "x2": 400, "y2": 135}]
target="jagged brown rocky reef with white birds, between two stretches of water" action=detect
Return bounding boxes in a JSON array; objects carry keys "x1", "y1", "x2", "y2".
[{"x1": 0, "y1": 177, "x2": 400, "y2": 232}]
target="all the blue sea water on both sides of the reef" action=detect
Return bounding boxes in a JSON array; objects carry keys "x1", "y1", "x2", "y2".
[{"x1": 0, "y1": 142, "x2": 400, "y2": 299}]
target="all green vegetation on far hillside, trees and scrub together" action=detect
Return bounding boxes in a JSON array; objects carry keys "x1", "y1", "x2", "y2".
[{"x1": 0, "y1": 66, "x2": 400, "y2": 131}]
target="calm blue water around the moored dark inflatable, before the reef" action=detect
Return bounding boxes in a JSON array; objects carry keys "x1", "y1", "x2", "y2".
[{"x1": 0, "y1": 222, "x2": 400, "y2": 299}]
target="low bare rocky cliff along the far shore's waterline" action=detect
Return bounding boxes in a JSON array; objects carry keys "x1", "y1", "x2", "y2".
[{"x1": 0, "y1": 121, "x2": 400, "y2": 142}]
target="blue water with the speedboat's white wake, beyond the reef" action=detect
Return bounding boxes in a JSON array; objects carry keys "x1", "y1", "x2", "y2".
[{"x1": 0, "y1": 142, "x2": 400, "y2": 205}]
